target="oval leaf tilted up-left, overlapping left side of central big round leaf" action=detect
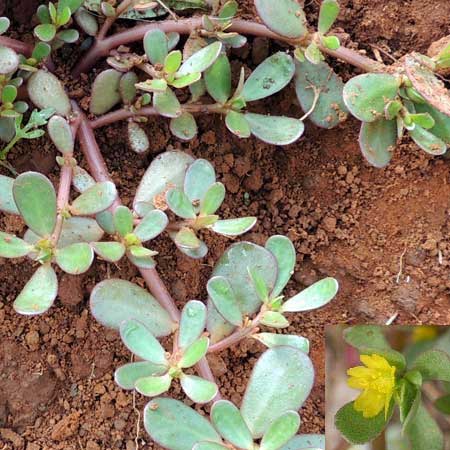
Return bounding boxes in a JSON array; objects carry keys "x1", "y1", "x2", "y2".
[{"x1": 206, "y1": 276, "x2": 243, "y2": 327}]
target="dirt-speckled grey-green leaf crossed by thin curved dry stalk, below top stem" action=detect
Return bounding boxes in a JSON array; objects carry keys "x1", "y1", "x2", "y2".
[{"x1": 295, "y1": 60, "x2": 348, "y2": 128}]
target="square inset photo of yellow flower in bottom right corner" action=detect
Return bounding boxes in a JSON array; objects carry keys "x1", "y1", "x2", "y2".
[{"x1": 325, "y1": 325, "x2": 450, "y2": 450}]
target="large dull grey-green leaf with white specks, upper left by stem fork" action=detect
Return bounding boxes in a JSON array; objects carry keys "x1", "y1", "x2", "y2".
[{"x1": 27, "y1": 69, "x2": 71, "y2": 117}]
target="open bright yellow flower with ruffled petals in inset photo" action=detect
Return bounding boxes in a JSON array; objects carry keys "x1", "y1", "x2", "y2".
[{"x1": 347, "y1": 354, "x2": 395, "y2": 419}]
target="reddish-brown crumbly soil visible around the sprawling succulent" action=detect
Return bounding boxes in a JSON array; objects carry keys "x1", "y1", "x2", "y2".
[{"x1": 0, "y1": 0, "x2": 450, "y2": 450}]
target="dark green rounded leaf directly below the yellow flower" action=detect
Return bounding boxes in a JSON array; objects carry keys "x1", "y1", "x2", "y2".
[{"x1": 334, "y1": 402, "x2": 394, "y2": 444}]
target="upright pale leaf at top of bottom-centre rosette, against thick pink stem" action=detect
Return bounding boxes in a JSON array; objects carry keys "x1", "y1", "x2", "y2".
[{"x1": 178, "y1": 300, "x2": 206, "y2": 349}]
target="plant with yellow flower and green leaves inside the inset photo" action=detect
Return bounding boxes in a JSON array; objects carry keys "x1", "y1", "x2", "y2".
[{"x1": 335, "y1": 325, "x2": 450, "y2": 450}]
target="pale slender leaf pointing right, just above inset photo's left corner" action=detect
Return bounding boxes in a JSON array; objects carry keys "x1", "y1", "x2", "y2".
[{"x1": 281, "y1": 277, "x2": 339, "y2": 312}]
